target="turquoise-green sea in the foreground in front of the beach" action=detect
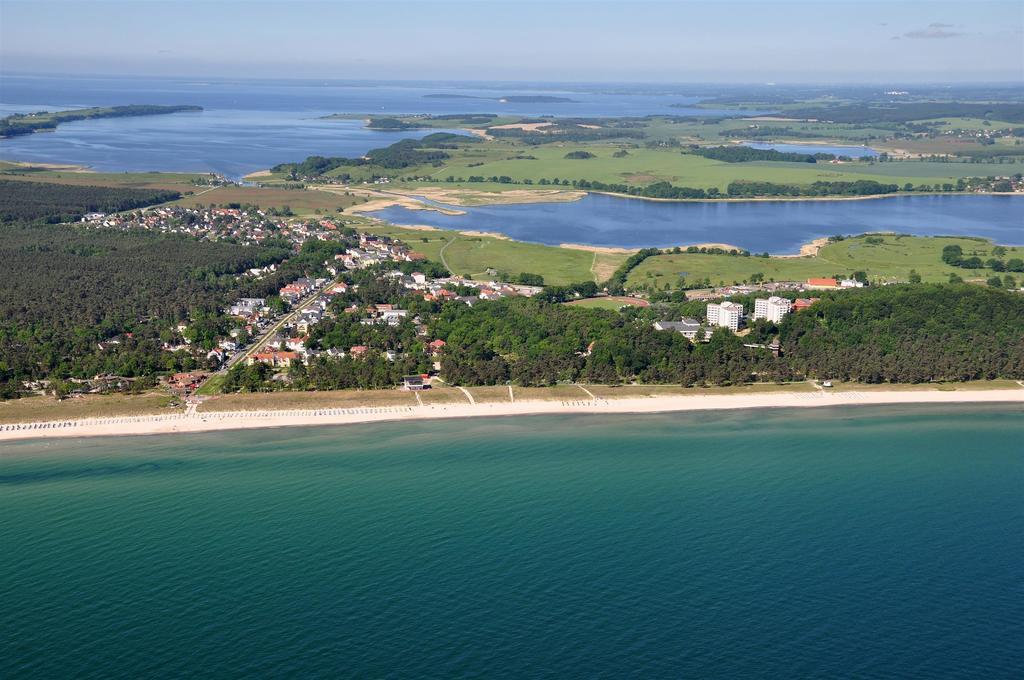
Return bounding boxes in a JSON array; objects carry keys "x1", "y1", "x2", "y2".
[{"x1": 0, "y1": 406, "x2": 1024, "y2": 679}]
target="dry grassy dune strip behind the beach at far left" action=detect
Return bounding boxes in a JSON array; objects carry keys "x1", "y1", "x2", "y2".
[{"x1": 0, "y1": 392, "x2": 183, "y2": 423}]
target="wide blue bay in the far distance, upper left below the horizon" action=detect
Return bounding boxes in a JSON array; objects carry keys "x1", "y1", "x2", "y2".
[{"x1": 0, "y1": 74, "x2": 764, "y2": 178}]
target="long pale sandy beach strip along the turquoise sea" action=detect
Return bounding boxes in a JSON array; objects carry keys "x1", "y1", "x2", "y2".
[{"x1": 0, "y1": 389, "x2": 1024, "y2": 441}]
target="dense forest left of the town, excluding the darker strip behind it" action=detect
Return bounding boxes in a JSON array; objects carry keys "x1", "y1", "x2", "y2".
[{"x1": 0, "y1": 218, "x2": 296, "y2": 397}]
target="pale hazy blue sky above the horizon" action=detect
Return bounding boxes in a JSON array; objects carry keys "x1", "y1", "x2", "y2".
[{"x1": 0, "y1": 0, "x2": 1024, "y2": 82}]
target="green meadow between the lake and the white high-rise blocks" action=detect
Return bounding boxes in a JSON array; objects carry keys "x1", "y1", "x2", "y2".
[{"x1": 627, "y1": 235, "x2": 1024, "y2": 290}]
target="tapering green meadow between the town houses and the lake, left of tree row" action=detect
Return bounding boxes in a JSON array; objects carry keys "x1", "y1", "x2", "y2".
[{"x1": 353, "y1": 221, "x2": 627, "y2": 286}]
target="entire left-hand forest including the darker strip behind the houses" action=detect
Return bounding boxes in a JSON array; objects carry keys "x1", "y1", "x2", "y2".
[{"x1": 0, "y1": 181, "x2": 374, "y2": 397}]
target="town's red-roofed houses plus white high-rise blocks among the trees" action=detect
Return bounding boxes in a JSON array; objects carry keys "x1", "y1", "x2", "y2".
[{"x1": 64, "y1": 199, "x2": 884, "y2": 397}]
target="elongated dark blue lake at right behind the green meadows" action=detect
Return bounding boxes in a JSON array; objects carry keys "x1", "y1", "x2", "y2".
[{"x1": 371, "y1": 194, "x2": 1024, "y2": 254}]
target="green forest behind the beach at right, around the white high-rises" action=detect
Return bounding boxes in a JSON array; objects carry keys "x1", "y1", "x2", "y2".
[{"x1": 431, "y1": 284, "x2": 1024, "y2": 385}]
